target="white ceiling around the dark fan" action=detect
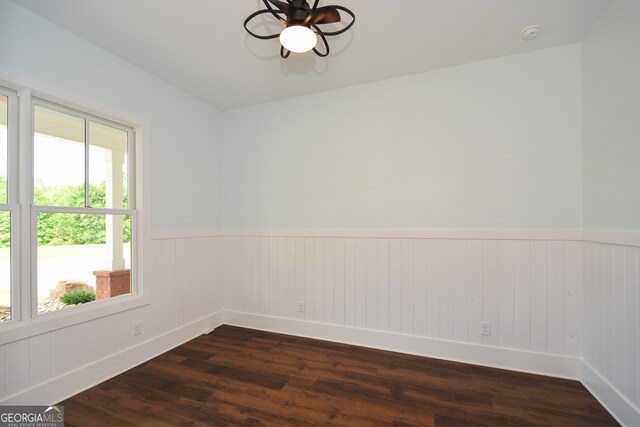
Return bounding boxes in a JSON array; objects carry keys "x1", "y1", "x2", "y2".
[{"x1": 13, "y1": 0, "x2": 610, "y2": 110}]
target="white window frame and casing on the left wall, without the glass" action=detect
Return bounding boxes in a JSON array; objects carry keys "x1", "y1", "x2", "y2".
[{"x1": 0, "y1": 80, "x2": 151, "y2": 345}]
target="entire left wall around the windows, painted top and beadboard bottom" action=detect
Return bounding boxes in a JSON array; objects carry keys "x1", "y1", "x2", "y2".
[{"x1": 0, "y1": 0, "x2": 223, "y2": 404}]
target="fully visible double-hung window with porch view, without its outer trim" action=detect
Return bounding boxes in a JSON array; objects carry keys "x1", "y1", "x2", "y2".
[{"x1": 32, "y1": 99, "x2": 135, "y2": 314}]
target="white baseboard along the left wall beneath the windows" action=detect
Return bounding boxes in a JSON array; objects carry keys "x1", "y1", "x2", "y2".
[{"x1": 0, "y1": 311, "x2": 223, "y2": 405}]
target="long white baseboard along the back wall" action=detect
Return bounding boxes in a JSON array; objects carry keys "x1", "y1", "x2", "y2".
[{"x1": 223, "y1": 311, "x2": 582, "y2": 380}]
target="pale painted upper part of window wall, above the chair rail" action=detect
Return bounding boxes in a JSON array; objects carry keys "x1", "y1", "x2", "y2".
[{"x1": 0, "y1": 0, "x2": 220, "y2": 228}]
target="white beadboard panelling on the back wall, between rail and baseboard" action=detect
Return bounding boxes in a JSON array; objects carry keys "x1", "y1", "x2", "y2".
[{"x1": 222, "y1": 235, "x2": 583, "y2": 356}]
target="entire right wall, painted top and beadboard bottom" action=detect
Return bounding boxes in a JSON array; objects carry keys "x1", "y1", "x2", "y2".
[{"x1": 582, "y1": 0, "x2": 640, "y2": 425}]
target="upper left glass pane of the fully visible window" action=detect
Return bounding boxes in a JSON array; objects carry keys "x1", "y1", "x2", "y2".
[{"x1": 33, "y1": 105, "x2": 85, "y2": 207}]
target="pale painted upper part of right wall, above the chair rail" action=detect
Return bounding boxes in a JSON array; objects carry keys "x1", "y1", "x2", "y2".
[{"x1": 582, "y1": 0, "x2": 640, "y2": 231}]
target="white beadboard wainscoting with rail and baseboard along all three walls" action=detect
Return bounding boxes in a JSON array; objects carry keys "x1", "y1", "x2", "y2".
[{"x1": 0, "y1": 230, "x2": 640, "y2": 425}]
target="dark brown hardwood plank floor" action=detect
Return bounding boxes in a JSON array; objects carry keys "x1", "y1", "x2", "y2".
[{"x1": 62, "y1": 326, "x2": 617, "y2": 426}]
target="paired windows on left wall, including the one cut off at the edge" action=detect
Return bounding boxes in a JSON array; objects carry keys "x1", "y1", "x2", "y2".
[{"x1": 0, "y1": 86, "x2": 140, "y2": 332}]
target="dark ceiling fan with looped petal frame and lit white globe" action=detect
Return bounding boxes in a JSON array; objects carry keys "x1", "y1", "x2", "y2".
[{"x1": 244, "y1": 0, "x2": 356, "y2": 59}]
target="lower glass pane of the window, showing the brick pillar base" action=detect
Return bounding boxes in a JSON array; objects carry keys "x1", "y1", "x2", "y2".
[{"x1": 37, "y1": 212, "x2": 131, "y2": 314}]
